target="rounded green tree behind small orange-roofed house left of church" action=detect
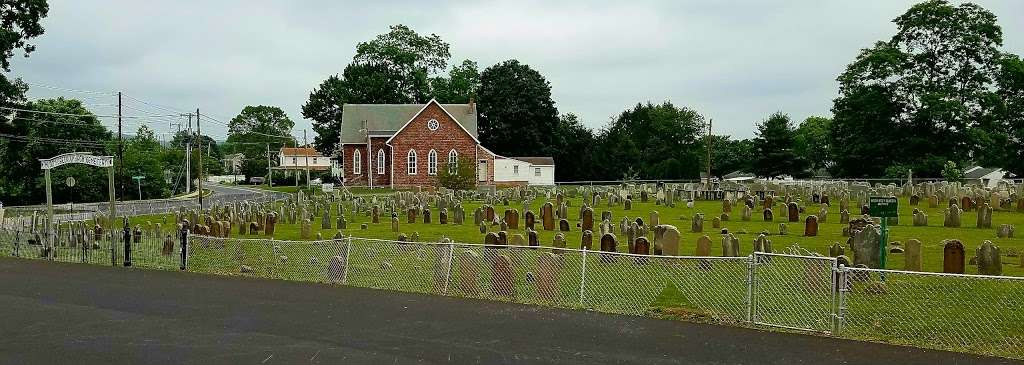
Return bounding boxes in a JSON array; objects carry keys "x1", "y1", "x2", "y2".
[{"x1": 224, "y1": 106, "x2": 295, "y2": 178}]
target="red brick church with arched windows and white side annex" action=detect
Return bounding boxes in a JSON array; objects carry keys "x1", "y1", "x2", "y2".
[{"x1": 339, "y1": 100, "x2": 555, "y2": 188}]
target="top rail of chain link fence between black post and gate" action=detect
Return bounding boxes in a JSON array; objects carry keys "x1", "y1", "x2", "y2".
[{"x1": 188, "y1": 234, "x2": 753, "y2": 261}]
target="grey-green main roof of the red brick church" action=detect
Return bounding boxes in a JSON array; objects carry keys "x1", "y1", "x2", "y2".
[{"x1": 341, "y1": 104, "x2": 479, "y2": 144}]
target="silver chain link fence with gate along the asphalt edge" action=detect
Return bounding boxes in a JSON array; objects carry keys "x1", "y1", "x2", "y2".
[{"x1": 0, "y1": 230, "x2": 1024, "y2": 359}]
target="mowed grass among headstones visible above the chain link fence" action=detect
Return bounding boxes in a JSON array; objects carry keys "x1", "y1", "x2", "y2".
[{"x1": 132, "y1": 197, "x2": 1024, "y2": 276}]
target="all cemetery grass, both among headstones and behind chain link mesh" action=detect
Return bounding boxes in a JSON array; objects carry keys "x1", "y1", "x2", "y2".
[{"x1": 22, "y1": 190, "x2": 1024, "y2": 359}]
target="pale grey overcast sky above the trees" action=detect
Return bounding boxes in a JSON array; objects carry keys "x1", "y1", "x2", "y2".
[{"x1": 11, "y1": 0, "x2": 1024, "y2": 139}]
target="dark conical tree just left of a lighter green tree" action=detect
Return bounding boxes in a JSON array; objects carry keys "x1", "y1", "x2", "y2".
[{"x1": 752, "y1": 112, "x2": 804, "y2": 178}]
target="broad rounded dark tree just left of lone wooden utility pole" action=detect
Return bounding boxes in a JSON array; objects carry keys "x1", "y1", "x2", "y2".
[{"x1": 593, "y1": 102, "x2": 705, "y2": 179}]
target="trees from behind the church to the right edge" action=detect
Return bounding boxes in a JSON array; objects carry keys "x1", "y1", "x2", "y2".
[{"x1": 302, "y1": 0, "x2": 1024, "y2": 181}]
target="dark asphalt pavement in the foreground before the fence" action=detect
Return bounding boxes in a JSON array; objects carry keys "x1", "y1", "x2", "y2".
[{"x1": 0, "y1": 258, "x2": 1011, "y2": 364}]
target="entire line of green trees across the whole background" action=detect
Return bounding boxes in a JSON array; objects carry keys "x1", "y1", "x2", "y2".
[{"x1": 0, "y1": 0, "x2": 1024, "y2": 204}]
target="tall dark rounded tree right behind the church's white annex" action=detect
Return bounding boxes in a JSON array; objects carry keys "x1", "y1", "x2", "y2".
[{"x1": 477, "y1": 59, "x2": 559, "y2": 157}]
